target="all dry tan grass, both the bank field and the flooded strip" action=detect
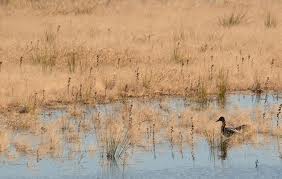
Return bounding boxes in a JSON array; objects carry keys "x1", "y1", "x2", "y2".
[{"x1": 0, "y1": 0, "x2": 282, "y2": 166}]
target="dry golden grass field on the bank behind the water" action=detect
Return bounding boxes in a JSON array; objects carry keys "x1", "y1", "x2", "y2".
[{"x1": 0, "y1": 0, "x2": 282, "y2": 111}]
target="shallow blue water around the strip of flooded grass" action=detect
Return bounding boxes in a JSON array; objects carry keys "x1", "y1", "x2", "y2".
[{"x1": 0, "y1": 93, "x2": 282, "y2": 178}]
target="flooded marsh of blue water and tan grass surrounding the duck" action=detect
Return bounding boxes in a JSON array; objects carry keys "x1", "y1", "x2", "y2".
[{"x1": 0, "y1": 93, "x2": 282, "y2": 177}]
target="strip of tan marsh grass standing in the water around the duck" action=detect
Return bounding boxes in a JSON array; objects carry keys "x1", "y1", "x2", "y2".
[{"x1": 0, "y1": 95, "x2": 282, "y2": 168}]
